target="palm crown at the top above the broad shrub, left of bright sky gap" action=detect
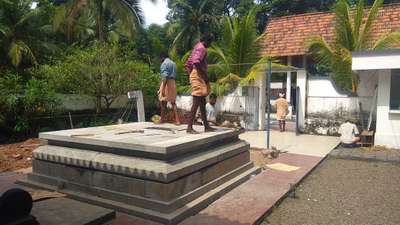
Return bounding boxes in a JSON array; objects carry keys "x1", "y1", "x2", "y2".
[{"x1": 53, "y1": 0, "x2": 156, "y2": 42}]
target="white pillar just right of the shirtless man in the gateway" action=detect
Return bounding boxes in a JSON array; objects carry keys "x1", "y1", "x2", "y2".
[{"x1": 297, "y1": 70, "x2": 307, "y2": 131}]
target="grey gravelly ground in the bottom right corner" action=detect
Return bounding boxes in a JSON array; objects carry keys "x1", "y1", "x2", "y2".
[{"x1": 262, "y1": 158, "x2": 400, "y2": 225}]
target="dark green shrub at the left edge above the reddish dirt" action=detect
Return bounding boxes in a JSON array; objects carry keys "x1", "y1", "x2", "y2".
[{"x1": 0, "y1": 71, "x2": 59, "y2": 138}]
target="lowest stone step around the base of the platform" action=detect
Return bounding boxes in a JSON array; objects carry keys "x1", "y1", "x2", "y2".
[{"x1": 17, "y1": 163, "x2": 261, "y2": 224}]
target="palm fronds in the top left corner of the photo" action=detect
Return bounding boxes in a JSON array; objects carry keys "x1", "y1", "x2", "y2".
[{"x1": 0, "y1": 0, "x2": 55, "y2": 67}]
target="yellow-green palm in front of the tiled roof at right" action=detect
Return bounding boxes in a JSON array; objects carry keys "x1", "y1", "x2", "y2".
[{"x1": 308, "y1": 0, "x2": 400, "y2": 93}]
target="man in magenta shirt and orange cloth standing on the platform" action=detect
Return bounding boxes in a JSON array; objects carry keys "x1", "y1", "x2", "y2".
[{"x1": 185, "y1": 34, "x2": 215, "y2": 134}]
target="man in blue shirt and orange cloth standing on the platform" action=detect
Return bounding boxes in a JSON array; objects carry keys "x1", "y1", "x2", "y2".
[{"x1": 158, "y1": 53, "x2": 181, "y2": 124}]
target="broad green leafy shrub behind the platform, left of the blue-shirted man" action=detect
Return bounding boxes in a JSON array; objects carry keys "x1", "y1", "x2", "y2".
[{"x1": 39, "y1": 43, "x2": 159, "y2": 113}]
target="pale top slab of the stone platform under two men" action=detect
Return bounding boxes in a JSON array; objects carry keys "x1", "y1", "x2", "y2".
[{"x1": 39, "y1": 122, "x2": 238, "y2": 155}]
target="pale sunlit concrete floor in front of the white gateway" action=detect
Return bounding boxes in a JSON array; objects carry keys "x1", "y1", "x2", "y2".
[{"x1": 240, "y1": 131, "x2": 340, "y2": 157}]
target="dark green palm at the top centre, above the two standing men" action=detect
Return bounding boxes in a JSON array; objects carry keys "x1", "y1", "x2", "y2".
[{"x1": 168, "y1": 0, "x2": 218, "y2": 53}]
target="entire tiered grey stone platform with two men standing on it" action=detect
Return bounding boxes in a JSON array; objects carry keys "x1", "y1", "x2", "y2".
[{"x1": 20, "y1": 123, "x2": 260, "y2": 224}]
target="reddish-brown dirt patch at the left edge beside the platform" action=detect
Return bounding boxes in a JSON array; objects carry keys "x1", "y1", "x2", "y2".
[{"x1": 0, "y1": 139, "x2": 40, "y2": 173}]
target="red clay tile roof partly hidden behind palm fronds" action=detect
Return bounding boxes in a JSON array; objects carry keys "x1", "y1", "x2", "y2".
[{"x1": 261, "y1": 4, "x2": 400, "y2": 56}]
